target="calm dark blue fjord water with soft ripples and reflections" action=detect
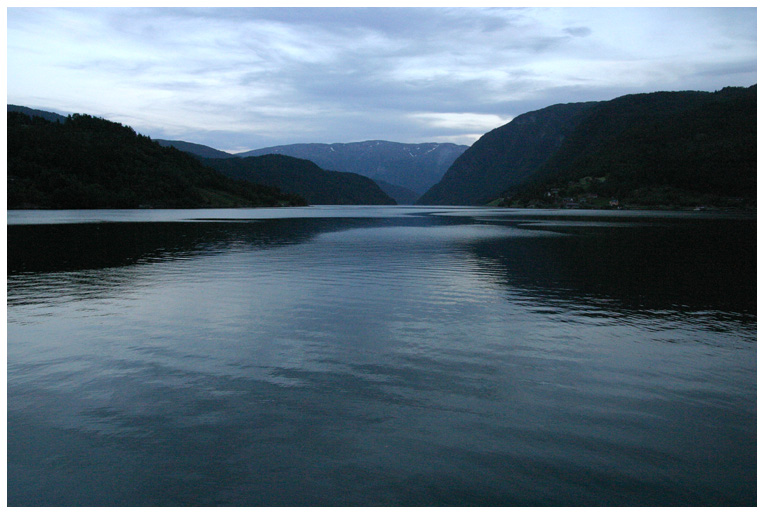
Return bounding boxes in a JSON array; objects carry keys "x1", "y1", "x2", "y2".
[{"x1": 7, "y1": 207, "x2": 756, "y2": 506}]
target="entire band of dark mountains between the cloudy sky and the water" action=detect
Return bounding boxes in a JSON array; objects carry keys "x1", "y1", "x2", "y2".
[{"x1": 7, "y1": 85, "x2": 757, "y2": 209}]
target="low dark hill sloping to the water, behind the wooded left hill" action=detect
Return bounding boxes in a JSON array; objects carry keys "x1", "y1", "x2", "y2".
[{"x1": 202, "y1": 154, "x2": 395, "y2": 205}]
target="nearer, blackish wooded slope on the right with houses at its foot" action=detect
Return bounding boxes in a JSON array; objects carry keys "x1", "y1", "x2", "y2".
[{"x1": 516, "y1": 86, "x2": 757, "y2": 206}]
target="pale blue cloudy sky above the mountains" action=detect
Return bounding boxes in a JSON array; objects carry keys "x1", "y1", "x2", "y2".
[{"x1": 7, "y1": 8, "x2": 756, "y2": 151}]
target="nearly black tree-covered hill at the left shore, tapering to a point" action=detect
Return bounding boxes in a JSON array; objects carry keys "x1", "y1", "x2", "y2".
[{"x1": 7, "y1": 110, "x2": 305, "y2": 209}]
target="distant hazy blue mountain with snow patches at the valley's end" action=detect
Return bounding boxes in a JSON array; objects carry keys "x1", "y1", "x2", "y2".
[{"x1": 237, "y1": 141, "x2": 467, "y2": 194}]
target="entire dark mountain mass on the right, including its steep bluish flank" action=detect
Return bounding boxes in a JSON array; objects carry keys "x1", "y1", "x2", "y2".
[{"x1": 418, "y1": 86, "x2": 756, "y2": 207}]
